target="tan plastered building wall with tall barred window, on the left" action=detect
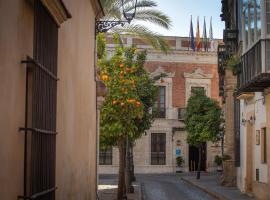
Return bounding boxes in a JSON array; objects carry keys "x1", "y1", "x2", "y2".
[{"x1": 0, "y1": 0, "x2": 103, "y2": 200}]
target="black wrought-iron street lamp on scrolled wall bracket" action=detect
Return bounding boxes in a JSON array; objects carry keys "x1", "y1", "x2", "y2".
[{"x1": 96, "y1": 0, "x2": 137, "y2": 33}]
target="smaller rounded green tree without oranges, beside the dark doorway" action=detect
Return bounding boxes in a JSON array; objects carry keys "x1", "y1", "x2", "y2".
[{"x1": 185, "y1": 90, "x2": 223, "y2": 179}]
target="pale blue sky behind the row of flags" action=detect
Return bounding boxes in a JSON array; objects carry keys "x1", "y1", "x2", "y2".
[{"x1": 138, "y1": 0, "x2": 224, "y2": 39}]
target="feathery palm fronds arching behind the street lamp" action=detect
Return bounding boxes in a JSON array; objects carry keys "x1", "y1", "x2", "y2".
[{"x1": 101, "y1": 0, "x2": 171, "y2": 52}]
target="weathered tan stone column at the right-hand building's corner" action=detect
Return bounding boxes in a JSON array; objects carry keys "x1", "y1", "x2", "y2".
[{"x1": 220, "y1": 70, "x2": 237, "y2": 186}]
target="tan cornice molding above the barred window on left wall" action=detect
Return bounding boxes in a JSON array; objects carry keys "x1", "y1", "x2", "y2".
[{"x1": 41, "y1": 0, "x2": 71, "y2": 26}]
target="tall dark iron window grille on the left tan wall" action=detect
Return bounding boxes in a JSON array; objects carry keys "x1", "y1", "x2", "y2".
[{"x1": 18, "y1": 0, "x2": 58, "y2": 200}]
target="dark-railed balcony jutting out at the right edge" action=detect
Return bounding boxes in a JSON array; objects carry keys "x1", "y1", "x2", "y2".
[{"x1": 237, "y1": 40, "x2": 270, "y2": 95}]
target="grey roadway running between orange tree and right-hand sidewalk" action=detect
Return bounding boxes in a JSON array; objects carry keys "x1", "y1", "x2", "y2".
[{"x1": 136, "y1": 174, "x2": 214, "y2": 200}]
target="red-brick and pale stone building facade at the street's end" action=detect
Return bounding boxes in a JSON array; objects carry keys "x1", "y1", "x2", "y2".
[{"x1": 99, "y1": 35, "x2": 221, "y2": 173}]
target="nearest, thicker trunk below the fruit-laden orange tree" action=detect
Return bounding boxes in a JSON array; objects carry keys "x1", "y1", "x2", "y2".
[{"x1": 117, "y1": 137, "x2": 127, "y2": 200}]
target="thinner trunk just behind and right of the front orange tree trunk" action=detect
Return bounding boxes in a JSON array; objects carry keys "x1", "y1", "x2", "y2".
[{"x1": 125, "y1": 137, "x2": 134, "y2": 193}]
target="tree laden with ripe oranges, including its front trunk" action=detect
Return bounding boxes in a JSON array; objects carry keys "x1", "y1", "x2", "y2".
[{"x1": 97, "y1": 34, "x2": 156, "y2": 199}]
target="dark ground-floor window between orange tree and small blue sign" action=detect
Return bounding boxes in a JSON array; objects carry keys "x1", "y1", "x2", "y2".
[{"x1": 151, "y1": 133, "x2": 166, "y2": 165}]
